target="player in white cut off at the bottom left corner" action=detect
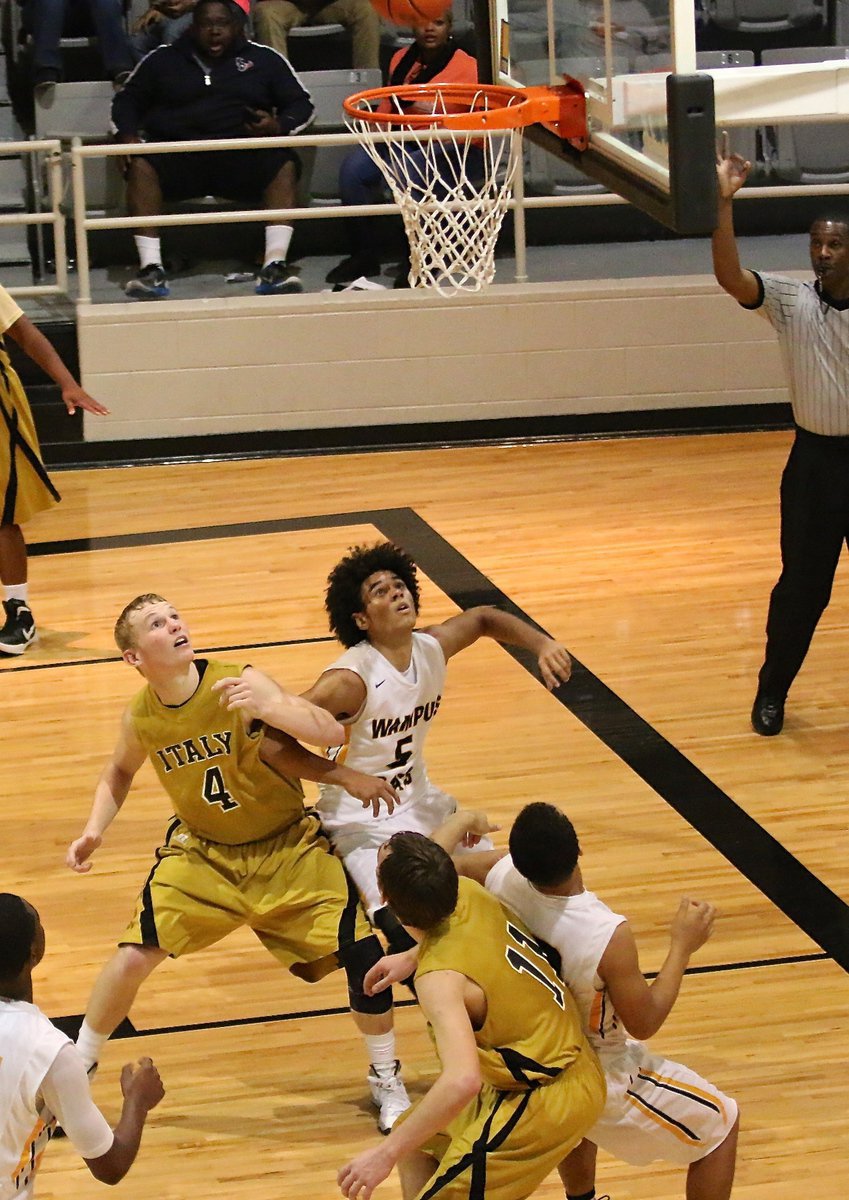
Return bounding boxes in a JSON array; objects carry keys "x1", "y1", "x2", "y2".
[{"x1": 0, "y1": 892, "x2": 164, "y2": 1200}]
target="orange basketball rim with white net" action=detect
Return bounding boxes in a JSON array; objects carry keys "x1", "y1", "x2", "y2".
[{"x1": 344, "y1": 79, "x2": 586, "y2": 295}]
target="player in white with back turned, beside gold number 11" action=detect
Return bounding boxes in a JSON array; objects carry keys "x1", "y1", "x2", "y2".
[{"x1": 366, "y1": 804, "x2": 739, "y2": 1200}]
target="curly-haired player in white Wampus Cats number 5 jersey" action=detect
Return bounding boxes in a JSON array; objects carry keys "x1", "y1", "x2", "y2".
[{"x1": 298, "y1": 542, "x2": 572, "y2": 1132}]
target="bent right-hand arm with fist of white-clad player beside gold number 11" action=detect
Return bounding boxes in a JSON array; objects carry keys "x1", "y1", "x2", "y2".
[{"x1": 598, "y1": 898, "x2": 716, "y2": 1039}]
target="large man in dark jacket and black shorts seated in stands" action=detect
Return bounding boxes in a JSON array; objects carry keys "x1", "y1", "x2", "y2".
[{"x1": 112, "y1": 0, "x2": 314, "y2": 300}]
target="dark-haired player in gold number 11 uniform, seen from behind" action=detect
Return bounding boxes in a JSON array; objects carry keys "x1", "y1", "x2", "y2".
[{"x1": 338, "y1": 833, "x2": 604, "y2": 1200}]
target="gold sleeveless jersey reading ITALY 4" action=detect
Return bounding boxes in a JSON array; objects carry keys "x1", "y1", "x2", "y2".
[{"x1": 130, "y1": 659, "x2": 303, "y2": 846}]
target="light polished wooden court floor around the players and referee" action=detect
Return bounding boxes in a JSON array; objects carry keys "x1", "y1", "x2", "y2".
[{"x1": 0, "y1": 433, "x2": 849, "y2": 1200}]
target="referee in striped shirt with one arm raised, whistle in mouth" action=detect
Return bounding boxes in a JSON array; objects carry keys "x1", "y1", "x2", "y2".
[{"x1": 713, "y1": 144, "x2": 849, "y2": 737}]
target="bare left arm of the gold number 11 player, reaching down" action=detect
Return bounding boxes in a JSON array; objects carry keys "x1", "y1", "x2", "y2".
[{"x1": 337, "y1": 971, "x2": 481, "y2": 1200}]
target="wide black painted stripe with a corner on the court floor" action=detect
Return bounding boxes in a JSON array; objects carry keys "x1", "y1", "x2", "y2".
[{"x1": 21, "y1": 508, "x2": 849, "y2": 971}]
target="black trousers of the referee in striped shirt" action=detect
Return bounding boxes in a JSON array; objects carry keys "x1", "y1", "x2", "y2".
[{"x1": 758, "y1": 428, "x2": 849, "y2": 697}]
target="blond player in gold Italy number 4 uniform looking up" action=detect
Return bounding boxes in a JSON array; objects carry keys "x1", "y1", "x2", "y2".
[{"x1": 67, "y1": 594, "x2": 393, "y2": 1118}]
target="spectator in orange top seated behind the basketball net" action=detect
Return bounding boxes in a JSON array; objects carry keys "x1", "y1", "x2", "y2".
[{"x1": 326, "y1": 11, "x2": 481, "y2": 287}]
